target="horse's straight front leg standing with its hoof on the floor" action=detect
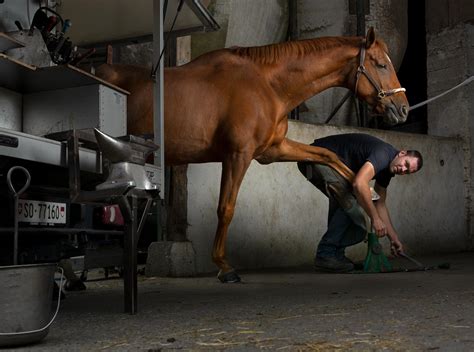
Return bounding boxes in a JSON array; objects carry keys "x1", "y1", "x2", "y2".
[{"x1": 212, "y1": 153, "x2": 252, "y2": 282}]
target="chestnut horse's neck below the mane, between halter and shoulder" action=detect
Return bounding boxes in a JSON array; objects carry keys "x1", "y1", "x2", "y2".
[{"x1": 271, "y1": 41, "x2": 359, "y2": 110}]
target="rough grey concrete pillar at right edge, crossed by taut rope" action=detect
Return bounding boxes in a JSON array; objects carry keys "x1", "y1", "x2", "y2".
[{"x1": 426, "y1": 0, "x2": 474, "y2": 249}]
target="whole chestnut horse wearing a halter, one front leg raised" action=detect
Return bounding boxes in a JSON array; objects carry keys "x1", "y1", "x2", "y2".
[{"x1": 97, "y1": 28, "x2": 408, "y2": 282}]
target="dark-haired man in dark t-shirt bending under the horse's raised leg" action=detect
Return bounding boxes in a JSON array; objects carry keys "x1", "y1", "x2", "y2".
[{"x1": 298, "y1": 133, "x2": 423, "y2": 272}]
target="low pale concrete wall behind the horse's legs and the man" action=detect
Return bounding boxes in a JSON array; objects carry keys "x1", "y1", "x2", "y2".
[{"x1": 188, "y1": 122, "x2": 468, "y2": 272}]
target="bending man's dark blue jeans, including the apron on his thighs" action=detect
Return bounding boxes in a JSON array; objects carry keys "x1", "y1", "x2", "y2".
[{"x1": 298, "y1": 163, "x2": 367, "y2": 259}]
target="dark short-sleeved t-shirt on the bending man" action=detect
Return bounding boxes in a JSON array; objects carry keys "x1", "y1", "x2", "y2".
[{"x1": 312, "y1": 133, "x2": 399, "y2": 188}]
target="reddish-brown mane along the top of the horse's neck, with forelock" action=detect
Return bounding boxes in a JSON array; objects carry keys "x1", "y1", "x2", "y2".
[{"x1": 229, "y1": 37, "x2": 388, "y2": 64}]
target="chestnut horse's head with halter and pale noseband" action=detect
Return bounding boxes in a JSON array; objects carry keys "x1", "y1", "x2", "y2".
[{"x1": 354, "y1": 27, "x2": 409, "y2": 125}]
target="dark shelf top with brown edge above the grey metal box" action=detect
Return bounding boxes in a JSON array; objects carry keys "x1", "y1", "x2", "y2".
[{"x1": 0, "y1": 53, "x2": 130, "y2": 95}]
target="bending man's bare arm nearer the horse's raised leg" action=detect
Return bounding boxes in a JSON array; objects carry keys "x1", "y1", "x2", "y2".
[{"x1": 352, "y1": 161, "x2": 387, "y2": 237}]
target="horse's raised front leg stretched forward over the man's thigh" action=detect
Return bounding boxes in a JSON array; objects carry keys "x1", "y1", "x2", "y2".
[{"x1": 256, "y1": 138, "x2": 354, "y2": 183}]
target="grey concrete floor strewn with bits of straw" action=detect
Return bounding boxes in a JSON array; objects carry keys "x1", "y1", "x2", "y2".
[{"x1": 6, "y1": 253, "x2": 474, "y2": 352}]
